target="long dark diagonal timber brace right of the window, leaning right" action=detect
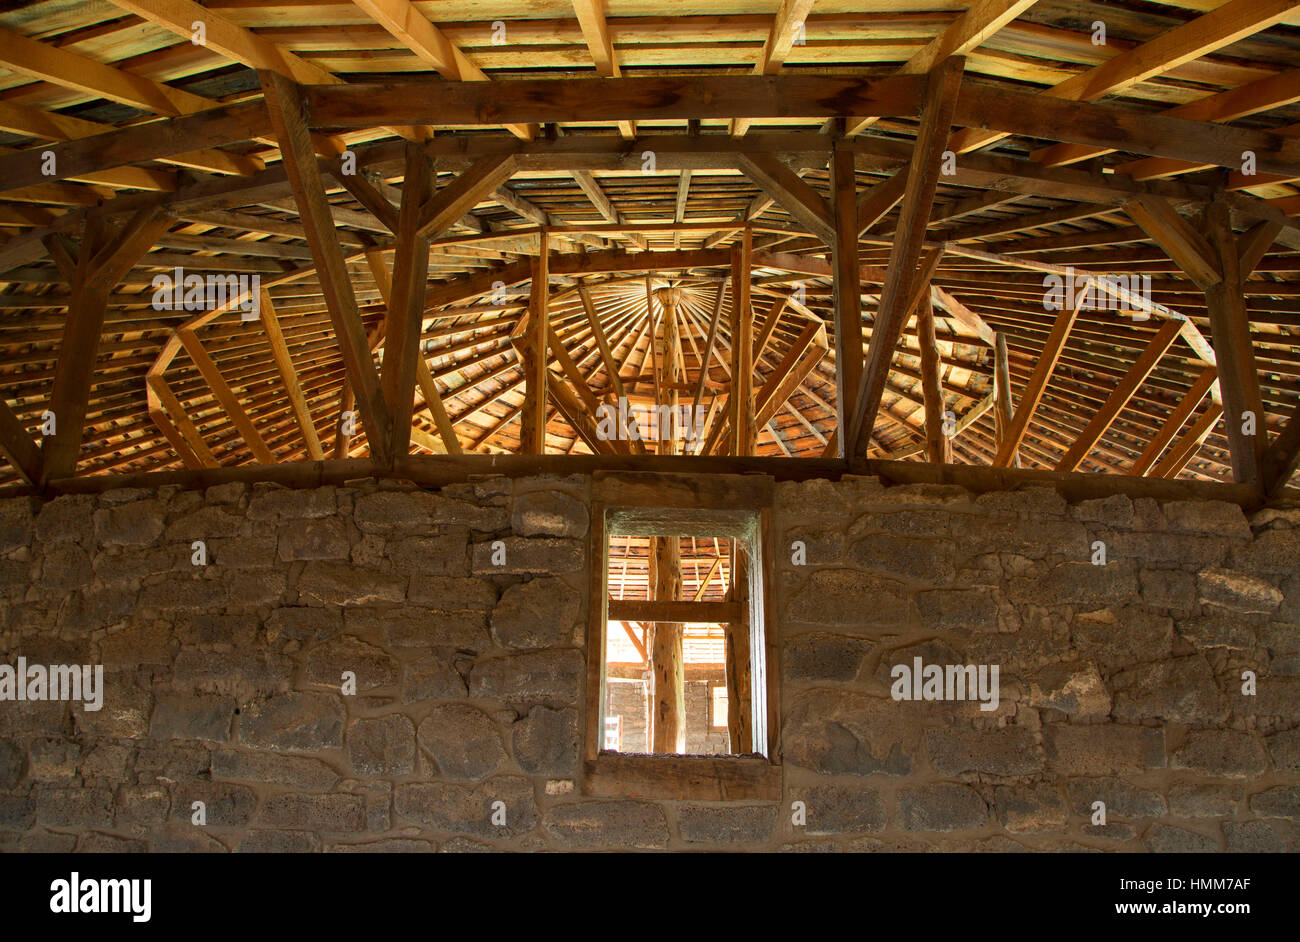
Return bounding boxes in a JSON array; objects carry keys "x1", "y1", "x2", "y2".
[{"x1": 841, "y1": 58, "x2": 965, "y2": 455}]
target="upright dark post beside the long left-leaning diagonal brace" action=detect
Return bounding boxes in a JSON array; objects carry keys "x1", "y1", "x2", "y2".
[{"x1": 380, "y1": 142, "x2": 433, "y2": 455}]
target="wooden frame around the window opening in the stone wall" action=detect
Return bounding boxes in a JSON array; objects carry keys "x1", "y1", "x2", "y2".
[{"x1": 582, "y1": 472, "x2": 781, "y2": 800}]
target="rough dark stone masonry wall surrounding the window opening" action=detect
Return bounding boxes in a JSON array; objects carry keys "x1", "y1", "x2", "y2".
[{"x1": 0, "y1": 476, "x2": 1300, "y2": 851}]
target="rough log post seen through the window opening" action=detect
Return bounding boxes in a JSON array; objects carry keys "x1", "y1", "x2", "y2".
[{"x1": 647, "y1": 537, "x2": 686, "y2": 755}]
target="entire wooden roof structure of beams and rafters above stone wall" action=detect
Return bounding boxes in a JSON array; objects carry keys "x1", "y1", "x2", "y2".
[{"x1": 0, "y1": 0, "x2": 1300, "y2": 491}]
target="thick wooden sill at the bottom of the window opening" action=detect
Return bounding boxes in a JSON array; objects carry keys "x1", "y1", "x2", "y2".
[{"x1": 582, "y1": 752, "x2": 781, "y2": 802}]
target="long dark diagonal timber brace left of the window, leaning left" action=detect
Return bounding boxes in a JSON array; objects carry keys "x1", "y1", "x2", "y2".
[{"x1": 259, "y1": 71, "x2": 393, "y2": 461}]
